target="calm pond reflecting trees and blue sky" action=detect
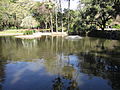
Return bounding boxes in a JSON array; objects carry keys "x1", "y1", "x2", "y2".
[{"x1": 0, "y1": 36, "x2": 120, "y2": 90}]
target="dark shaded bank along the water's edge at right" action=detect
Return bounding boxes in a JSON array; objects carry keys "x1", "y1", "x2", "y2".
[{"x1": 69, "y1": 30, "x2": 120, "y2": 40}]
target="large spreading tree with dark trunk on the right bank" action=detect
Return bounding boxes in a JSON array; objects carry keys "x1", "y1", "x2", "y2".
[{"x1": 81, "y1": 0, "x2": 119, "y2": 30}]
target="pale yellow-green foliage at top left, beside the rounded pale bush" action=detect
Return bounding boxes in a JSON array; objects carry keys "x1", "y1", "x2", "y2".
[{"x1": 0, "y1": 0, "x2": 34, "y2": 29}]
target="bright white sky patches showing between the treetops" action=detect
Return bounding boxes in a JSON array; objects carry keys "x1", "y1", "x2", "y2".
[{"x1": 34, "y1": 0, "x2": 79, "y2": 10}]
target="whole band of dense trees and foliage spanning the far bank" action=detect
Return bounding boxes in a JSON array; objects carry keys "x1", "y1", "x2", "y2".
[{"x1": 0, "y1": 0, "x2": 120, "y2": 34}]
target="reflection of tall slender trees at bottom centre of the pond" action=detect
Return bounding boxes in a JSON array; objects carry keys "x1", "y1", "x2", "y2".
[{"x1": 53, "y1": 55, "x2": 79, "y2": 90}]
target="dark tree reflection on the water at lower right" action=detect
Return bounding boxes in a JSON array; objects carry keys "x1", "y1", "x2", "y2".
[{"x1": 79, "y1": 52, "x2": 120, "y2": 90}]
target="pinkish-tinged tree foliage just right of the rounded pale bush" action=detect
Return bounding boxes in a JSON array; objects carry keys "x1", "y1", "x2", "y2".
[{"x1": 31, "y1": 2, "x2": 54, "y2": 28}]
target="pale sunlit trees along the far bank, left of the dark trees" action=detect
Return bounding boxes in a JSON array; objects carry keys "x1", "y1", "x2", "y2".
[{"x1": 0, "y1": 0, "x2": 72, "y2": 32}]
